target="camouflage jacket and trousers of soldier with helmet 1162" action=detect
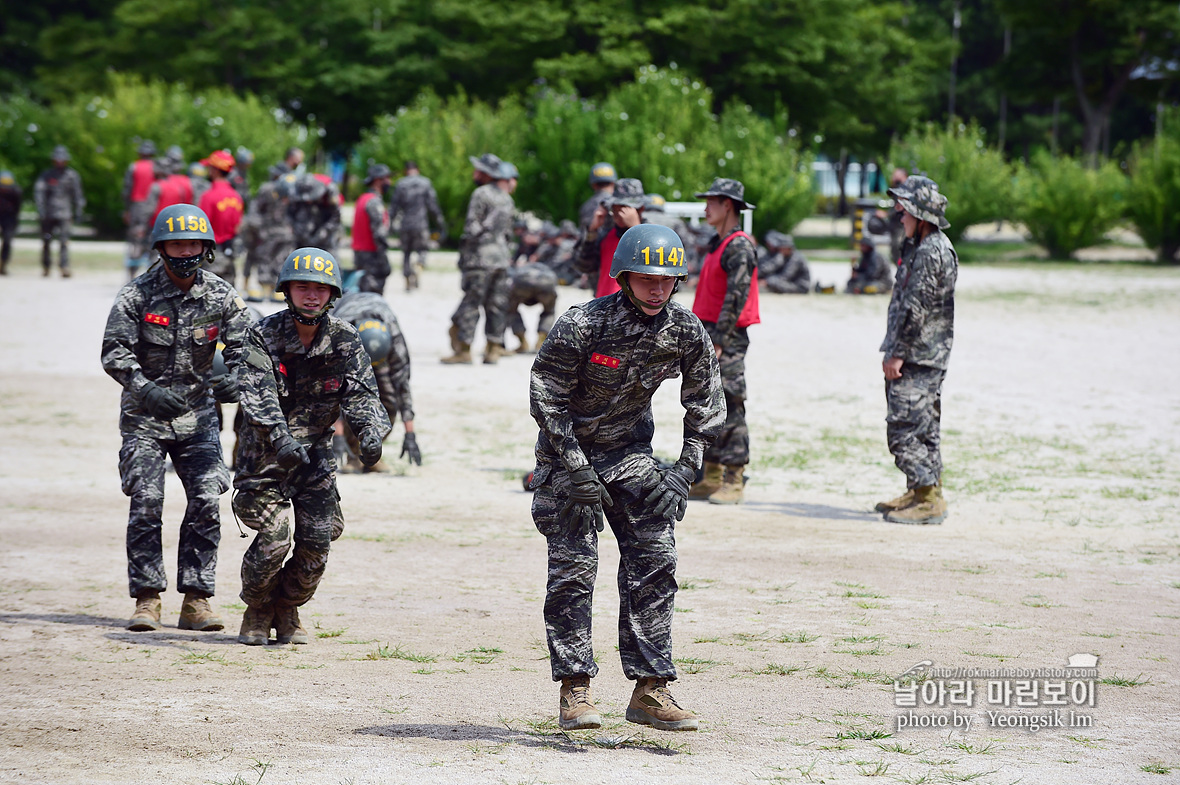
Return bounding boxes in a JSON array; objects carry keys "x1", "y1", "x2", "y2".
[{"x1": 234, "y1": 310, "x2": 389, "y2": 607}]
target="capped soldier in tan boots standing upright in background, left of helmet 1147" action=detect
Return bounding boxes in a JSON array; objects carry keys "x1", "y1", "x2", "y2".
[{"x1": 443, "y1": 153, "x2": 516, "y2": 365}]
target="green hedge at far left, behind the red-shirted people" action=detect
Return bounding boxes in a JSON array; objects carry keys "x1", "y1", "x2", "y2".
[{"x1": 0, "y1": 76, "x2": 308, "y2": 233}]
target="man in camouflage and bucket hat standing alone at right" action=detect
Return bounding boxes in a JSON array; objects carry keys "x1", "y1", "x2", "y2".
[{"x1": 877, "y1": 176, "x2": 958, "y2": 524}]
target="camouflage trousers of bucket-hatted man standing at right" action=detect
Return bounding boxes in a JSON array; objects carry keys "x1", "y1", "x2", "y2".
[{"x1": 885, "y1": 362, "x2": 946, "y2": 488}]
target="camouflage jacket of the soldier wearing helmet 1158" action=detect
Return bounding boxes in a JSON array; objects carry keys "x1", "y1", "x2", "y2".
[{"x1": 103, "y1": 264, "x2": 254, "y2": 439}]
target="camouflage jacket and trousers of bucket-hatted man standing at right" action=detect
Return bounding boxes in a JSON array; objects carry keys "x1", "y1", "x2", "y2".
[{"x1": 880, "y1": 231, "x2": 958, "y2": 489}]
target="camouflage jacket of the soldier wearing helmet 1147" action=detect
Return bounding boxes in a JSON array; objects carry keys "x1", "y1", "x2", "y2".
[{"x1": 529, "y1": 292, "x2": 726, "y2": 484}]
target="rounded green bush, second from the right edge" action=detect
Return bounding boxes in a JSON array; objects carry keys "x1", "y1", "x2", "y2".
[{"x1": 1016, "y1": 153, "x2": 1127, "y2": 259}]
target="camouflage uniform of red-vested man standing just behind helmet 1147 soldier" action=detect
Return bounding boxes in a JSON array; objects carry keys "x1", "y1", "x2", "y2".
[{"x1": 703, "y1": 227, "x2": 756, "y2": 466}]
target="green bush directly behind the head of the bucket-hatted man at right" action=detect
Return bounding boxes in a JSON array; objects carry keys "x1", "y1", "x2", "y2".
[{"x1": 890, "y1": 123, "x2": 1012, "y2": 241}]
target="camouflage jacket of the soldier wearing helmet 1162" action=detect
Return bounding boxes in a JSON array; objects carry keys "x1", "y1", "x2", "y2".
[{"x1": 234, "y1": 309, "x2": 391, "y2": 489}]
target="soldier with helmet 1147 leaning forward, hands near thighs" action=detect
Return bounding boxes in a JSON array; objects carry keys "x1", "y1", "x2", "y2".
[{"x1": 530, "y1": 225, "x2": 725, "y2": 731}]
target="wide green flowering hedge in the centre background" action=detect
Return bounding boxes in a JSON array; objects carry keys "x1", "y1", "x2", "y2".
[{"x1": 356, "y1": 67, "x2": 814, "y2": 230}]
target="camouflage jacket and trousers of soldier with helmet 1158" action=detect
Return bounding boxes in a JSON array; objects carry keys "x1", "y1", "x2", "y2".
[{"x1": 103, "y1": 263, "x2": 254, "y2": 597}]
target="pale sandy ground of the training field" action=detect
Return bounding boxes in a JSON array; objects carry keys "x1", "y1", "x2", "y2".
[{"x1": 0, "y1": 249, "x2": 1180, "y2": 785}]
